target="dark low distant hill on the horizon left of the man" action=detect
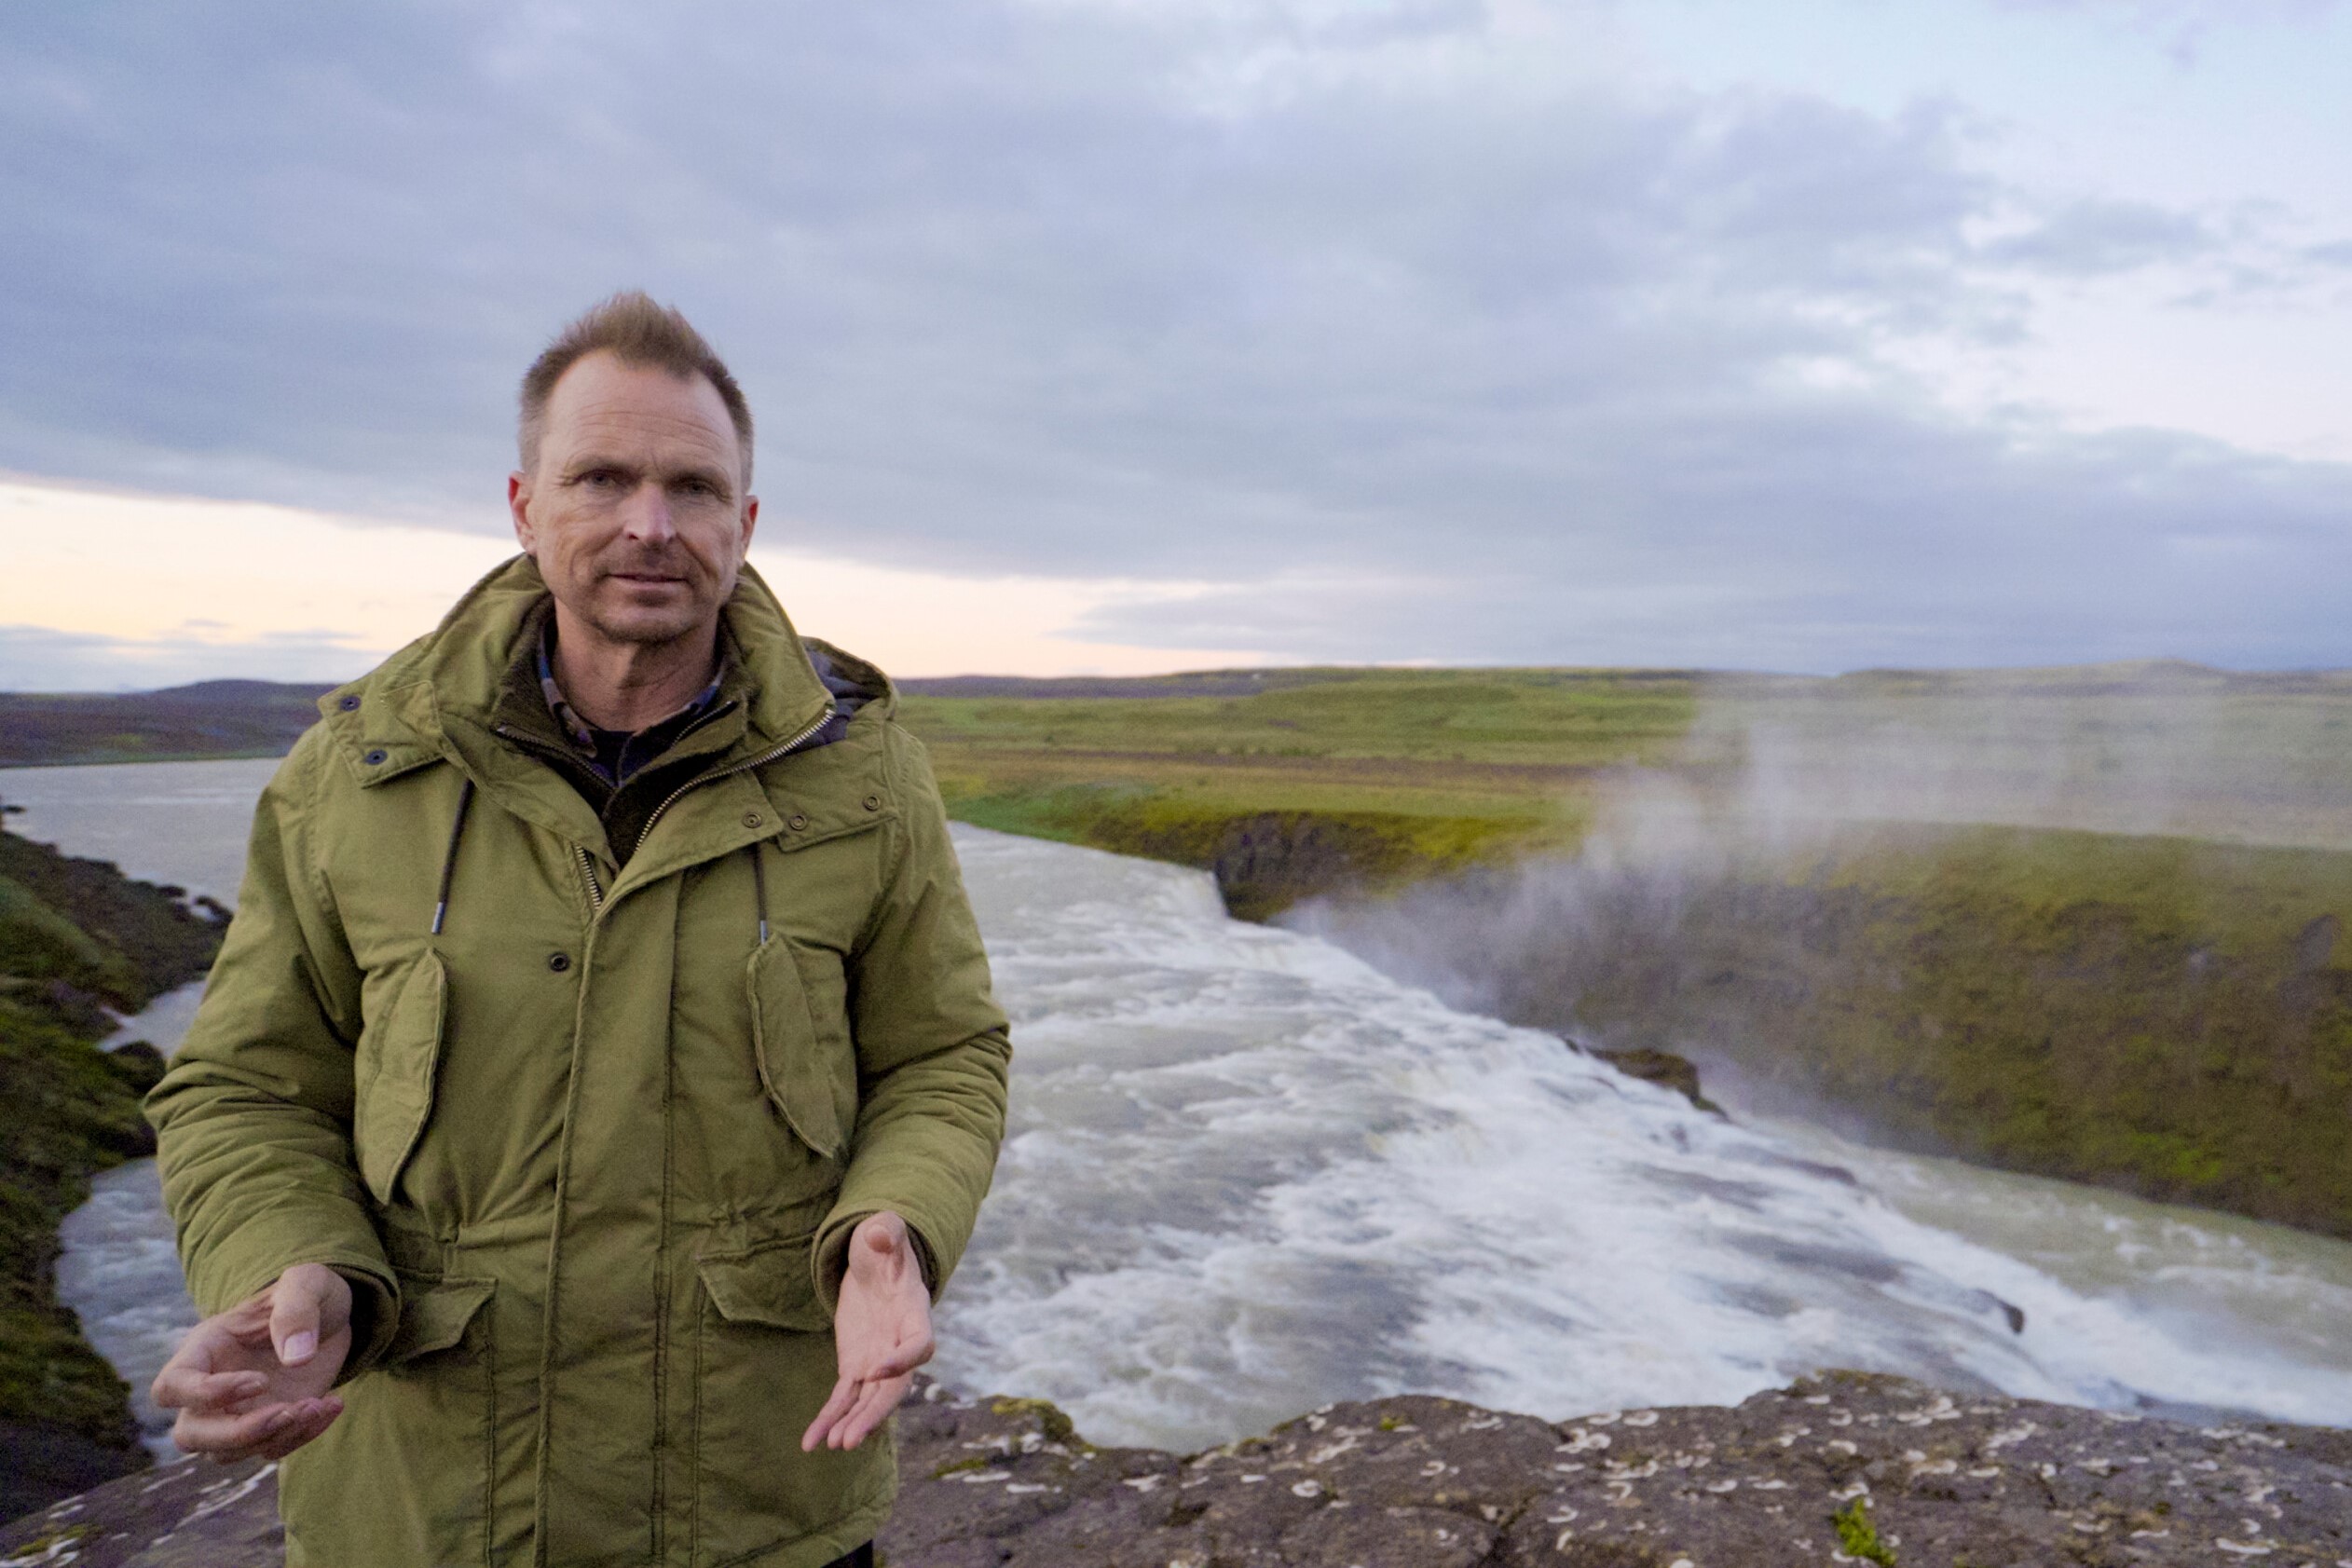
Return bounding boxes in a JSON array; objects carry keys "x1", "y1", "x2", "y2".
[{"x1": 0, "y1": 679, "x2": 329, "y2": 767}]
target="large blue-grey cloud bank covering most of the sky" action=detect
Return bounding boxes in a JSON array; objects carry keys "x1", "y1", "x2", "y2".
[{"x1": 0, "y1": 0, "x2": 2352, "y2": 668}]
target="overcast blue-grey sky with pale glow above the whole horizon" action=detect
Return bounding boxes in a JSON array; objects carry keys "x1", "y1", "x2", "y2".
[{"x1": 0, "y1": 0, "x2": 2352, "y2": 689}]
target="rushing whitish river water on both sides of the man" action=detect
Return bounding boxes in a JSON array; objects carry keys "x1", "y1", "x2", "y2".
[{"x1": 0, "y1": 762, "x2": 2352, "y2": 1448}]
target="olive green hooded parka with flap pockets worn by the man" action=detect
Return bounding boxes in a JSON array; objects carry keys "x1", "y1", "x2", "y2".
[{"x1": 148, "y1": 557, "x2": 1009, "y2": 1568}]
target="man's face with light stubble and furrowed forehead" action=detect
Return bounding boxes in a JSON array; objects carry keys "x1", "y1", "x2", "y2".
[{"x1": 506, "y1": 352, "x2": 759, "y2": 644}]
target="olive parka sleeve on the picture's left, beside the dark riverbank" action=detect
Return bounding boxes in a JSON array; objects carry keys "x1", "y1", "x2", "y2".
[{"x1": 145, "y1": 731, "x2": 398, "y2": 1378}]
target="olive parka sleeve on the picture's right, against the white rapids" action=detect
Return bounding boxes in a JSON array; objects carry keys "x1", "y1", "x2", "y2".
[{"x1": 816, "y1": 727, "x2": 1011, "y2": 1312}]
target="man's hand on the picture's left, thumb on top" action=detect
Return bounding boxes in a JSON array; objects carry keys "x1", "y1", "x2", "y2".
[{"x1": 153, "y1": 1262, "x2": 350, "y2": 1465}]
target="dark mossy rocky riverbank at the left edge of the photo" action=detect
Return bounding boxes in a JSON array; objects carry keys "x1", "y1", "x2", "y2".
[{"x1": 0, "y1": 832, "x2": 221, "y2": 1516}]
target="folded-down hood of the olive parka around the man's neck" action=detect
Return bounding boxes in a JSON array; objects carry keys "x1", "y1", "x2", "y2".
[{"x1": 318, "y1": 554, "x2": 898, "y2": 781}]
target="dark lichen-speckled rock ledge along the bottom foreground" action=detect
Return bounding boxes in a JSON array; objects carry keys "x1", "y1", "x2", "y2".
[{"x1": 18, "y1": 1373, "x2": 2352, "y2": 1568}]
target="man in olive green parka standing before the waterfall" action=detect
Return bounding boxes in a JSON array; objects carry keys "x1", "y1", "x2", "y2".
[{"x1": 151, "y1": 293, "x2": 1009, "y2": 1568}]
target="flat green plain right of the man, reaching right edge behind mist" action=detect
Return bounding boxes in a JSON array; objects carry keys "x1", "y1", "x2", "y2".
[{"x1": 903, "y1": 663, "x2": 2352, "y2": 915}]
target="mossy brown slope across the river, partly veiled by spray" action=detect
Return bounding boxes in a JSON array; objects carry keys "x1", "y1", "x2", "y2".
[{"x1": 1329, "y1": 827, "x2": 2352, "y2": 1236}]
